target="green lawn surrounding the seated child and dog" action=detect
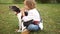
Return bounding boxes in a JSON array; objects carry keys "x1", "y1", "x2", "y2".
[{"x1": 0, "y1": 4, "x2": 60, "y2": 34}]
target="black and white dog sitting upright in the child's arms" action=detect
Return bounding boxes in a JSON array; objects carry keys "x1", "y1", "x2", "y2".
[{"x1": 9, "y1": 6, "x2": 28, "y2": 31}]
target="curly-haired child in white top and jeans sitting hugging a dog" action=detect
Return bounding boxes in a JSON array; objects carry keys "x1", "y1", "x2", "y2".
[{"x1": 21, "y1": 0, "x2": 43, "y2": 31}]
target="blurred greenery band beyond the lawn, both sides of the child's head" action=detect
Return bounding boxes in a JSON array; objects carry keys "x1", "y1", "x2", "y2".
[{"x1": 0, "y1": 0, "x2": 60, "y2": 4}]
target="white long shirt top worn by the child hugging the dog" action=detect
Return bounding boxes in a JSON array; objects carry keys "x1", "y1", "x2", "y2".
[{"x1": 22, "y1": 8, "x2": 40, "y2": 21}]
